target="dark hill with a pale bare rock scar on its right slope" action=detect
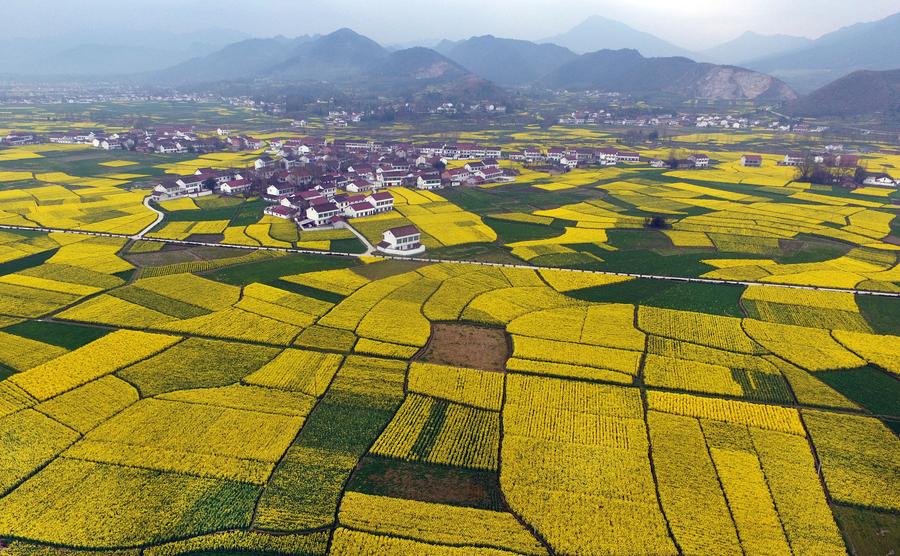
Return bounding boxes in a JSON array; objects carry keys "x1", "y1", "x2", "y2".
[{"x1": 539, "y1": 49, "x2": 797, "y2": 101}]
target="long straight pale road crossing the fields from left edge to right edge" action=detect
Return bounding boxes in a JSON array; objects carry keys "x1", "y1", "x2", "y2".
[{"x1": 0, "y1": 225, "x2": 900, "y2": 298}]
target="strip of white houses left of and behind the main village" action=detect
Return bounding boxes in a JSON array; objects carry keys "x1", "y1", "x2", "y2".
[{"x1": 47, "y1": 126, "x2": 224, "y2": 154}]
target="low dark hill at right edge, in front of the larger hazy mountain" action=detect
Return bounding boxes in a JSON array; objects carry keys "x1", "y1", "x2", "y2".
[{"x1": 785, "y1": 70, "x2": 900, "y2": 119}]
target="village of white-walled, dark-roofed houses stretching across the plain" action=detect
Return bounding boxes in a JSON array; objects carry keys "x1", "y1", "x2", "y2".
[{"x1": 0, "y1": 121, "x2": 898, "y2": 237}]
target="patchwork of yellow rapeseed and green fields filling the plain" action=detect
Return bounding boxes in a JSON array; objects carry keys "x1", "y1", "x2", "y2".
[{"x1": 0, "y1": 102, "x2": 900, "y2": 555}]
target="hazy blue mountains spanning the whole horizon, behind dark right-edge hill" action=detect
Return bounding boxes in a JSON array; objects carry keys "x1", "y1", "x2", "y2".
[{"x1": 0, "y1": 14, "x2": 900, "y2": 108}]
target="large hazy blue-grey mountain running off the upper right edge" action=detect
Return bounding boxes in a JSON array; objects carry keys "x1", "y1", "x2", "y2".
[{"x1": 748, "y1": 13, "x2": 900, "y2": 91}]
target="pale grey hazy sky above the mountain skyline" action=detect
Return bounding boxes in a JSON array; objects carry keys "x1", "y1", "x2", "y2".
[{"x1": 7, "y1": 0, "x2": 900, "y2": 49}]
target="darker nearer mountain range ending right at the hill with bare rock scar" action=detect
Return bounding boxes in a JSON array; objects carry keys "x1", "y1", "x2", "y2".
[{"x1": 148, "y1": 29, "x2": 796, "y2": 101}]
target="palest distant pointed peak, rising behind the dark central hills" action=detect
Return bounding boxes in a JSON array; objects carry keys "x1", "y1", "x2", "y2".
[{"x1": 539, "y1": 15, "x2": 694, "y2": 57}]
